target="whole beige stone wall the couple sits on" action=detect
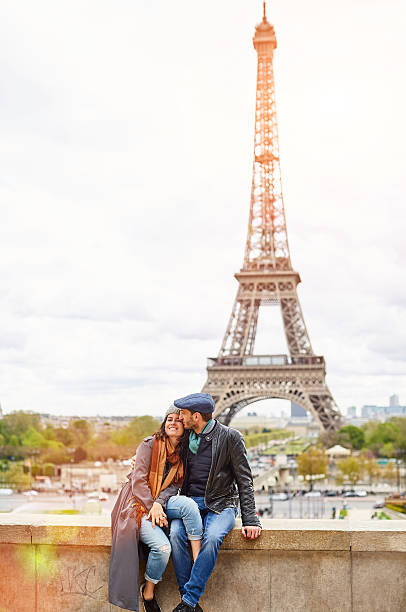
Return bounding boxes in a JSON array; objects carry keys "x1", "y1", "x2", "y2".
[{"x1": 0, "y1": 514, "x2": 406, "y2": 612}]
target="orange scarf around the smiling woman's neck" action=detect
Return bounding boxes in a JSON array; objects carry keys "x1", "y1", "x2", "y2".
[{"x1": 132, "y1": 437, "x2": 183, "y2": 527}]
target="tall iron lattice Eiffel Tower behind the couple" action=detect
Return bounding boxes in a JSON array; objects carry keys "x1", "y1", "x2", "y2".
[{"x1": 203, "y1": 2, "x2": 343, "y2": 431}]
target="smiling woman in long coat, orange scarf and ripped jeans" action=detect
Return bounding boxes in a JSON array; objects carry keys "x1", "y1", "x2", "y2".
[{"x1": 109, "y1": 406, "x2": 203, "y2": 612}]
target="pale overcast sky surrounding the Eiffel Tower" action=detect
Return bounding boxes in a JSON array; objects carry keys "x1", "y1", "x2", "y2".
[{"x1": 0, "y1": 0, "x2": 406, "y2": 415}]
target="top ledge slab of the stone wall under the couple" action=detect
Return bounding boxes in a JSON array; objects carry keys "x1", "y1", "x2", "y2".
[{"x1": 0, "y1": 513, "x2": 406, "y2": 552}]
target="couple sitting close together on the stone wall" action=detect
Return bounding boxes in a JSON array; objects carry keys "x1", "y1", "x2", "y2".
[{"x1": 109, "y1": 393, "x2": 261, "y2": 612}]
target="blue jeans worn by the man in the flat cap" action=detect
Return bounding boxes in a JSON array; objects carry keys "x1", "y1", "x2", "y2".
[{"x1": 170, "y1": 497, "x2": 237, "y2": 607}]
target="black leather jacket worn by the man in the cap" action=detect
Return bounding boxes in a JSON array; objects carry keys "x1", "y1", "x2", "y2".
[{"x1": 181, "y1": 421, "x2": 261, "y2": 527}]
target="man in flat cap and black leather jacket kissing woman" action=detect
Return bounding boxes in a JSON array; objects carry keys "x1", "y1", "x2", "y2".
[{"x1": 170, "y1": 393, "x2": 261, "y2": 612}]
